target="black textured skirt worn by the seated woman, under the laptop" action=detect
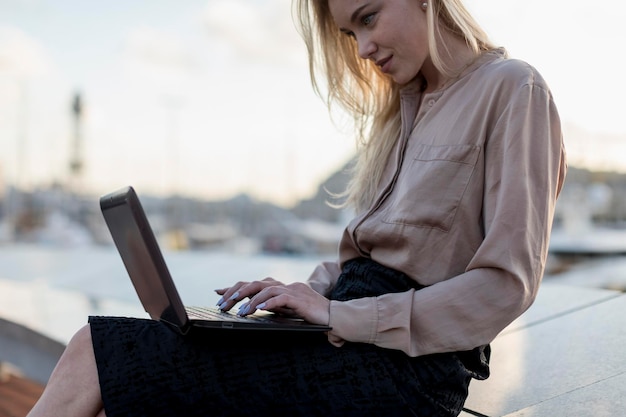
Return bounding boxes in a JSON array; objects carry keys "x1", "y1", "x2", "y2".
[{"x1": 89, "y1": 259, "x2": 489, "y2": 417}]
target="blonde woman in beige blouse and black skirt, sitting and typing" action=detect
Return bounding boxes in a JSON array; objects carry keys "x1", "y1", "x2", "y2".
[{"x1": 30, "y1": 0, "x2": 565, "y2": 417}]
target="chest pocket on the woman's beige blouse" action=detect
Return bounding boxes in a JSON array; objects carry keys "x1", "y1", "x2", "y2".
[{"x1": 383, "y1": 145, "x2": 480, "y2": 232}]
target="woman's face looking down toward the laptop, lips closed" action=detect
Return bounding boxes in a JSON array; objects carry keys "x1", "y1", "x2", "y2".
[{"x1": 328, "y1": 0, "x2": 429, "y2": 84}]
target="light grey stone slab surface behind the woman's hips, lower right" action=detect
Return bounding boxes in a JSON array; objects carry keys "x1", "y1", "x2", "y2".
[{"x1": 461, "y1": 281, "x2": 626, "y2": 417}]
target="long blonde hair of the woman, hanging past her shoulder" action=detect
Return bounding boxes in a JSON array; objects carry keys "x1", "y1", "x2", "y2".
[{"x1": 293, "y1": 0, "x2": 494, "y2": 212}]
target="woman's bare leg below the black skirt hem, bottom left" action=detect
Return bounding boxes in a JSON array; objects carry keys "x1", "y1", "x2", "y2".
[{"x1": 27, "y1": 325, "x2": 104, "y2": 417}]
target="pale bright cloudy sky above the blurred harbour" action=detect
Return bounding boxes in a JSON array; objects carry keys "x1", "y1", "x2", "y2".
[{"x1": 0, "y1": 0, "x2": 626, "y2": 205}]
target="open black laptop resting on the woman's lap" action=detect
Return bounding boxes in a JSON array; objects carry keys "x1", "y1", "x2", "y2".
[{"x1": 100, "y1": 186, "x2": 331, "y2": 334}]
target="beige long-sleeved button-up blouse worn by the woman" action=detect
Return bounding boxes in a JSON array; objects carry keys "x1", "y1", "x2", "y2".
[{"x1": 308, "y1": 50, "x2": 566, "y2": 356}]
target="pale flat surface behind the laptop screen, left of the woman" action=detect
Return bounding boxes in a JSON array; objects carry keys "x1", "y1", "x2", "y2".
[{"x1": 0, "y1": 245, "x2": 322, "y2": 343}]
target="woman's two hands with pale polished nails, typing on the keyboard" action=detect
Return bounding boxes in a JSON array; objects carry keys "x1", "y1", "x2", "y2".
[{"x1": 216, "y1": 278, "x2": 330, "y2": 325}]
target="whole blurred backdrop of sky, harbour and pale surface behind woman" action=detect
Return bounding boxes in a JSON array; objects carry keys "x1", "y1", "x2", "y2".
[{"x1": 0, "y1": 0, "x2": 626, "y2": 341}]
